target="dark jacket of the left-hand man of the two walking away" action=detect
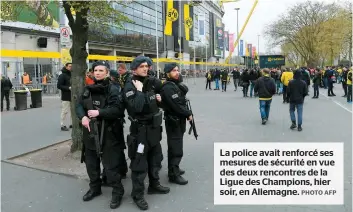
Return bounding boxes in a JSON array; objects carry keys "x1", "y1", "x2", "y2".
[{"x1": 254, "y1": 75, "x2": 276, "y2": 98}]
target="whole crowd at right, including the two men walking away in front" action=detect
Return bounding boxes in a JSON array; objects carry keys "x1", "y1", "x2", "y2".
[{"x1": 205, "y1": 66, "x2": 352, "y2": 131}]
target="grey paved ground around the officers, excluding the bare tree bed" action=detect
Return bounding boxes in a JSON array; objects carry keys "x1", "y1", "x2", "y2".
[{"x1": 1, "y1": 79, "x2": 352, "y2": 212}]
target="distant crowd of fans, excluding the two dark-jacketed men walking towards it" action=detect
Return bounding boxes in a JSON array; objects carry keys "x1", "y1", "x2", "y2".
[{"x1": 206, "y1": 66, "x2": 352, "y2": 103}]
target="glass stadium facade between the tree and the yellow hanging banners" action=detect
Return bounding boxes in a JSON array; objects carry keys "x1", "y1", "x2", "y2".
[{"x1": 89, "y1": 0, "x2": 163, "y2": 51}]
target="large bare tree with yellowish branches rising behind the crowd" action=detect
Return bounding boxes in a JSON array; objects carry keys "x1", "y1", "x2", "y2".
[{"x1": 265, "y1": 1, "x2": 338, "y2": 67}]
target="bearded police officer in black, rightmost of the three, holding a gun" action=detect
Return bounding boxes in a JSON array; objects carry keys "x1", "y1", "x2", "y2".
[{"x1": 161, "y1": 63, "x2": 192, "y2": 185}]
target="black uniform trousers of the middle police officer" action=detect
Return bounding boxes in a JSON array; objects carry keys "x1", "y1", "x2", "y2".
[{"x1": 128, "y1": 125, "x2": 163, "y2": 198}]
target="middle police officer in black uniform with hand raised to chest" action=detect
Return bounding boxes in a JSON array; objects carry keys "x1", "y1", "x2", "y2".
[{"x1": 123, "y1": 56, "x2": 170, "y2": 210}]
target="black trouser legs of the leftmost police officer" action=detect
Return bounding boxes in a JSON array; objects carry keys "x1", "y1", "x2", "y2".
[{"x1": 85, "y1": 142, "x2": 124, "y2": 196}]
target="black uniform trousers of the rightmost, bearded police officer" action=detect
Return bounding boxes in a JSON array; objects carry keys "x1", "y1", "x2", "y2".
[{"x1": 165, "y1": 116, "x2": 186, "y2": 177}]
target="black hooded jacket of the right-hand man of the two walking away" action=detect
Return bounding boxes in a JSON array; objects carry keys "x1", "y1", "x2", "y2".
[{"x1": 287, "y1": 71, "x2": 308, "y2": 104}]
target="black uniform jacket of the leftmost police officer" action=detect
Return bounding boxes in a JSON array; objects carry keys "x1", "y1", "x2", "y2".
[{"x1": 76, "y1": 80, "x2": 125, "y2": 150}]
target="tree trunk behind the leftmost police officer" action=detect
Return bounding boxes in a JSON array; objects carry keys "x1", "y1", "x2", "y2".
[{"x1": 70, "y1": 22, "x2": 88, "y2": 152}]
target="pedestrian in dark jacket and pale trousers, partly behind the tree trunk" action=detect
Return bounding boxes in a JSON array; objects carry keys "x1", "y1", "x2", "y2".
[{"x1": 57, "y1": 63, "x2": 72, "y2": 131}]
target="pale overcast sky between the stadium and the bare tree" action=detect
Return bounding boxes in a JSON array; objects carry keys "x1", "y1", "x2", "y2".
[{"x1": 223, "y1": 0, "x2": 338, "y2": 53}]
